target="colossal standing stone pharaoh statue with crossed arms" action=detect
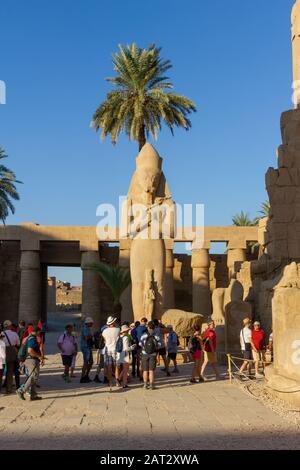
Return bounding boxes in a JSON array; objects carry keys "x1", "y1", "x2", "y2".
[{"x1": 126, "y1": 144, "x2": 175, "y2": 320}]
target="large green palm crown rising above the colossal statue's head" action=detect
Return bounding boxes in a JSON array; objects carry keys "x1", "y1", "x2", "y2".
[{"x1": 91, "y1": 44, "x2": 196, "y2": 149}]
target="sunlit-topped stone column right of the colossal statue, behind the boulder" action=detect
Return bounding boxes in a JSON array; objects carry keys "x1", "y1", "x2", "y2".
[{"x1": 192, "y1": 248, "x2": 211, "y2": 317}]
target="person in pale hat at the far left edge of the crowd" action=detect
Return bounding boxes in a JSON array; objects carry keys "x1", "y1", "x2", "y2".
[{"x1": 3, "y1": 320, "x2": 20, "y2": 394}]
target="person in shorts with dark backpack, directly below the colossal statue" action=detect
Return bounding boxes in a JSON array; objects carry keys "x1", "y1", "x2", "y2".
[{"x1": 140, "y1": 321, "x2": 161, "y2": 390}]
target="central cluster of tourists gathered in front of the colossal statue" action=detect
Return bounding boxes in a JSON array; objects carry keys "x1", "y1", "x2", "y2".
[{"x1": 58, "y1": 316, "x2": 220, "y2": 389}]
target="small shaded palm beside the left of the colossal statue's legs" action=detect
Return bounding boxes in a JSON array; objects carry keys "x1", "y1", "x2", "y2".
[{"x1": 89, "y1": 262, "x2": 131, "y2": 320}]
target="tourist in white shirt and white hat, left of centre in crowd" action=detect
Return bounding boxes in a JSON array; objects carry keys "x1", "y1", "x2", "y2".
[{"x1": 102, "y1": 316, "x2": 120, "y2": 389}]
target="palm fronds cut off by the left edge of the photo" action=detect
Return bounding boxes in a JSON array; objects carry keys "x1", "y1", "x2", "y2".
[{"x1": 0, "y1": 147, "x2": 21, "y2": 224}]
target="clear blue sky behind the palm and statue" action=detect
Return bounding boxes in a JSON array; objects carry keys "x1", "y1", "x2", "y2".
[{"x1": 0, "y1": 0, "x2": 294, "y2": 282}]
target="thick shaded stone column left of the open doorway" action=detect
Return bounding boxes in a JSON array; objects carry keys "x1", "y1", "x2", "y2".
[{"x1": 19, "y1": 250, "x2": 41, "y2": 323}]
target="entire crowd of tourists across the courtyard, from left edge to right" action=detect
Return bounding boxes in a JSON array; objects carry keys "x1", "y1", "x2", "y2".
[{"x1": 0, "y1": 316, "x2": 273, "y2": 401}]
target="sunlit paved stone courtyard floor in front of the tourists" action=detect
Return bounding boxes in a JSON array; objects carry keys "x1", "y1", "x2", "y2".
[{"x1": 0, "y1": 318, "x2": 300, "y2": 450}]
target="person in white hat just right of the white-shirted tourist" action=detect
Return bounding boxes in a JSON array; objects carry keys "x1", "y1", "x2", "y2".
[{"x1": 116, "y1": 325, "x2": 136, "y2": 389}]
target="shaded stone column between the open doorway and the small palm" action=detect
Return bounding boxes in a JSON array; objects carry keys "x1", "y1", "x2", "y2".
[{"x1": 81, "y1": 251, "x2": 105, "y2": 329}]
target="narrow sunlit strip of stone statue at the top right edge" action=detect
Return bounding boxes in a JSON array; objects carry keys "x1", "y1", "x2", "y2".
[{"x1": 292, "y1": 0, "x2": 300, "y2": 108}]
